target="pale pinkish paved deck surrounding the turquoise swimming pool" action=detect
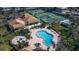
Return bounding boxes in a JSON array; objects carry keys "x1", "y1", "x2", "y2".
[{"x1": 29, "y1": 28, "x2": 58, "y2": 51}]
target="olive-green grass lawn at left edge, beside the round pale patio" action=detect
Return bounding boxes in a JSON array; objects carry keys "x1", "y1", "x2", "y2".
[{"x1": 0, "y1": 27, "x2": 15, "y2": 51}]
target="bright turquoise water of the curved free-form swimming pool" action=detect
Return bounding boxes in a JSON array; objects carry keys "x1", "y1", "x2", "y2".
[{"x1": 36, "y1": 31, "x2": 53, "y2": 46}]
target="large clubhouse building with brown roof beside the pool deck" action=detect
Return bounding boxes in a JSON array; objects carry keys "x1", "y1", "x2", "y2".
[{"x1": 8, "y1": 13, "x2": 40, "y2": 30}]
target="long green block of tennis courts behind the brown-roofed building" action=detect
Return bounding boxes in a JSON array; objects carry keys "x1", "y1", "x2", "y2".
[{"x1": 29, "y1": 10, "x2": 66, "y2": 23}]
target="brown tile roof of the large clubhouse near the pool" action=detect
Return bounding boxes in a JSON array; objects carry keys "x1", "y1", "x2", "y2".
[{"x1": 9, "y1": 13, "x2": 39, "y2": 28}]
